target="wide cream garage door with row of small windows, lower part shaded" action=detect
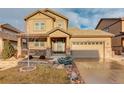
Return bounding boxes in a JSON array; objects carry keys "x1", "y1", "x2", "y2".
[{"x1": 71, "y1": 41, "x2": 104, "y2": 58}]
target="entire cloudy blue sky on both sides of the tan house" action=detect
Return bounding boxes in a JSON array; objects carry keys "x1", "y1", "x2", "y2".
[{"x1": 0, "y1": 8, "x2": 124, "y2": 31}]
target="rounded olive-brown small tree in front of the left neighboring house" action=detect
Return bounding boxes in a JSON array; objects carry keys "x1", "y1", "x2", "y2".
[{"x1": 2, "y1": 41, "x2": 15, "y2": 59}]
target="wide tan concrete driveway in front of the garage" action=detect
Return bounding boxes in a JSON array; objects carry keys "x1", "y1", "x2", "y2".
[{"x1": 75, "y1": 59, "x2": 124, "y2": 84}]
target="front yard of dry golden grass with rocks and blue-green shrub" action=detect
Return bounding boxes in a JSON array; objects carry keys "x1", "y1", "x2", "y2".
[{"x1": 0, "y1": 56, "x2": 84, "y2": 84}]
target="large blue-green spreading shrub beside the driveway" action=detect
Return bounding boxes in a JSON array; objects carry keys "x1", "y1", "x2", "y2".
[{"x1": 58, "y1": 56, "x2": 73, "y2": 65}]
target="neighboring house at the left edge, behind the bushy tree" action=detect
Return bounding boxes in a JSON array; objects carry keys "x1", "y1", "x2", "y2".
[{"x1": 0, "y1": 24, "x2": 20, "y2": 54}]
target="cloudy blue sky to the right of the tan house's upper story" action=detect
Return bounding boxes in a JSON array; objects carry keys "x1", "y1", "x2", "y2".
[{"x1": 55, "y1": 8, "x2": 124, "y2": 29}]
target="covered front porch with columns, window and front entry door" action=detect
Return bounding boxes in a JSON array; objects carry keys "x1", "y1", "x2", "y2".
[{"x1": 17, "y1": 35, "x2": 70, "y2": 58}]
